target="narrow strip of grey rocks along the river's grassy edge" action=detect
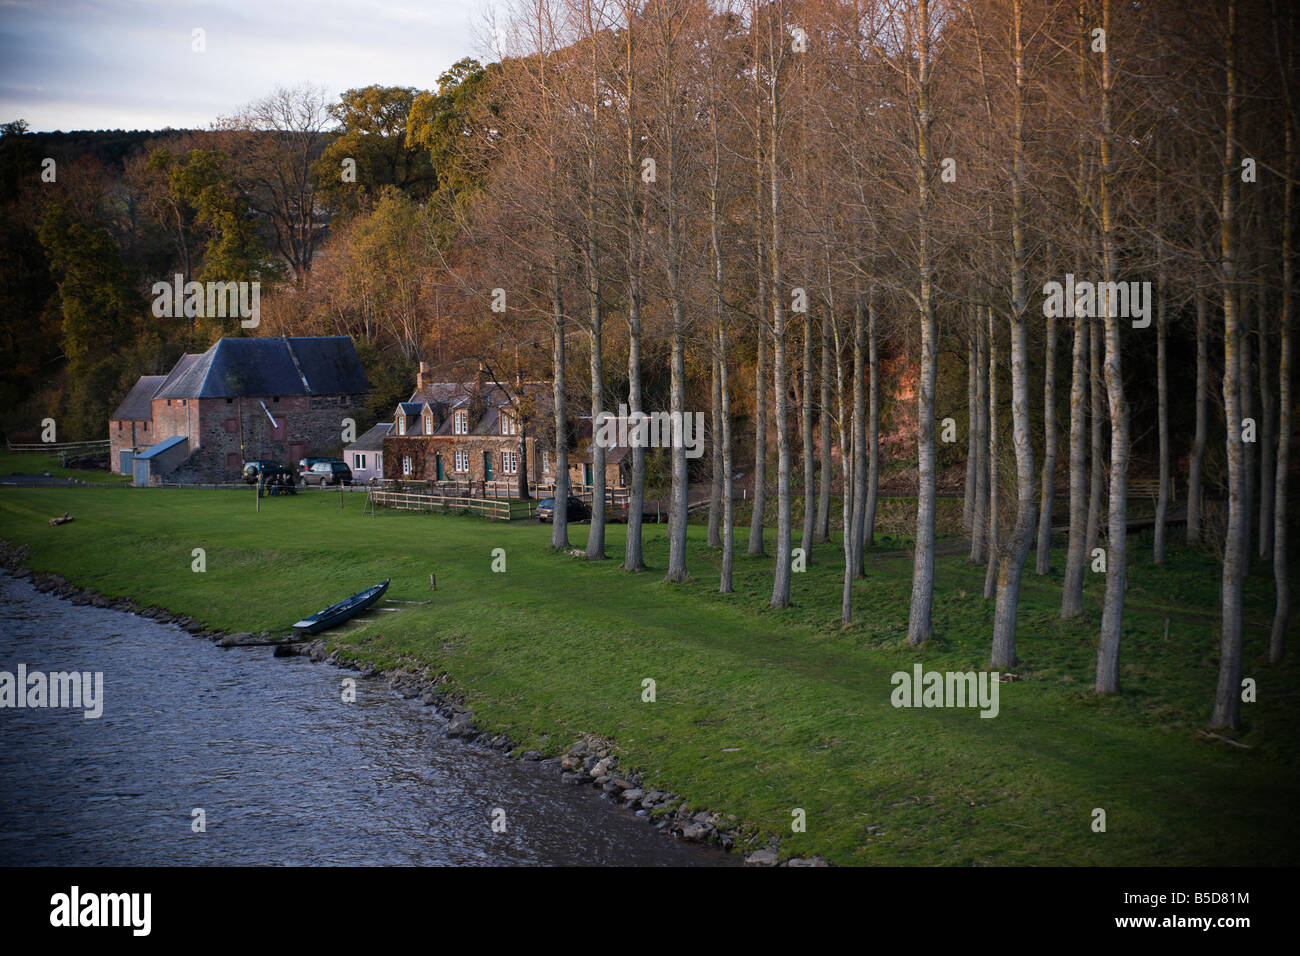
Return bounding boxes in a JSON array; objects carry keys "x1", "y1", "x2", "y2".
[{"x1": 0, "y1": 541, "x2": 827, "y2": 866}]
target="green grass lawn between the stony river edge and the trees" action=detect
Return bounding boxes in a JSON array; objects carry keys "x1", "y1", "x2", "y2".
[{"x1": 0, "y1": 489, "x2": 1300, "y2": 865}]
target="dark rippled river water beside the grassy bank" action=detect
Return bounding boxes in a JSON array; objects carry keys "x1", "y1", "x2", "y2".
[{"x1": 0, "y1": 574, "x2": 740, "y2": 866}]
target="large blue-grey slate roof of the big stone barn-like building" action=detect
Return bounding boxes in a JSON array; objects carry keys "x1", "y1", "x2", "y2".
[{"x1": 153, "y1": 336, "x2": 371, "y2": 398}]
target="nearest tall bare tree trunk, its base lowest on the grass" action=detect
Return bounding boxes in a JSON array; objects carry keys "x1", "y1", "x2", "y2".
[{"x1": 1210, "y1": 0, "x2": 1245, "y2": 730}]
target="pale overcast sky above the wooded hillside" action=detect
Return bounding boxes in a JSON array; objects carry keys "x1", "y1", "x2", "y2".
[{"x1": 0, "y1": 0, "x2": 491, "y2": 130}]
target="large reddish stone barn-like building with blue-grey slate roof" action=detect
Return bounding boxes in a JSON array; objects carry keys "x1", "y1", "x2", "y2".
[{"x1": 109, "y1": 336, "x2": 369, "y2": 483}]
